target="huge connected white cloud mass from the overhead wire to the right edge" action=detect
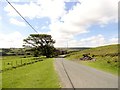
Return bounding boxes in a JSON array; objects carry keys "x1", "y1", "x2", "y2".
[{"x1": 4, "y1": 0, "x2": 119, "y2": 46}]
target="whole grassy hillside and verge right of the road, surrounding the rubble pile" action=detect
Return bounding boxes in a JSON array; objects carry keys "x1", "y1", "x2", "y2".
[{"x1": 67, "y1": 44, "x2": 120, "y2": 75}]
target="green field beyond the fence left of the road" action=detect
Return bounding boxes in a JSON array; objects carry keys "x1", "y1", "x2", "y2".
[{"x1": 2, "y1": 56, "x2": 43, "y2": 70}]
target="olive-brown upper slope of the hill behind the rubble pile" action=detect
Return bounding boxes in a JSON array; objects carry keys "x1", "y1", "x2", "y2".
[{"x1": 69, "y1": 44, "x2": 120, "y2": 59}]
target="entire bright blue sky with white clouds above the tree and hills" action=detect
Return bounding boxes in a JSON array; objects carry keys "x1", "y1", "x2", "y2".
[{"x1": 0, "y1": 0, "x2": 119, "y2": 48}]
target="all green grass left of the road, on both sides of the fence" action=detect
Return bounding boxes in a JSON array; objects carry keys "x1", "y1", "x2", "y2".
[{"x1": 0, "y1": 56, "x2": 60, "y2": 88}]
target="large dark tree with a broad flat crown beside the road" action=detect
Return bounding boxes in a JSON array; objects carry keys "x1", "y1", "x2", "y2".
[{"x1": 23, "y1": 34, "x2": 55, "y2": 58}]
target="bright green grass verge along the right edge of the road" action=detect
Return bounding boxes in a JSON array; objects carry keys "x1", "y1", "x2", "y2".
[{"x1": 67, "y1": 55, "x2": 120, "y2": 76}]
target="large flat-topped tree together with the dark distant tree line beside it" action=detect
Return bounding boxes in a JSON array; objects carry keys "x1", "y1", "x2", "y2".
[{"x1": 0, "y1": 34, "x2": 67, "y2": 58}]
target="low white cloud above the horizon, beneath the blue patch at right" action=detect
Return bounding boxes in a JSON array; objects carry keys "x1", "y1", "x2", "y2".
[{"x1": 64, "y1": 34, "x2": 105, "y2": 47}]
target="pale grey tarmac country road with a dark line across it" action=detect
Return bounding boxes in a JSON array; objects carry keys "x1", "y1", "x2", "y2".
[{"x1": 55, "y1": 58, "x2": 118, "y2": 88}]
